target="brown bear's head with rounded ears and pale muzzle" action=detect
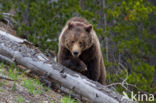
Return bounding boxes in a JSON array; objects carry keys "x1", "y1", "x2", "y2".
[{"x1": 64, "y1": 22, "x2": 93, "y2": 57}]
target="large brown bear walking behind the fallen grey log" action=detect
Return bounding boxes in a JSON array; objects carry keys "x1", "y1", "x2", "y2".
[{"x1": 58, "y1": 17, "x2": 106, "y2": 84}]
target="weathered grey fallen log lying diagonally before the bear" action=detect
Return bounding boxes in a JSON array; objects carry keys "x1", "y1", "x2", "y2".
[{"x1": 0, "y1": 30, "x2": 136, "y2": 103}]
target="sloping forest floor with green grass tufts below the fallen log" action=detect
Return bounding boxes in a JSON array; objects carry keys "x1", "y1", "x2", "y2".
[{"x1": 0, "y1": 63, "x2": 77, "y2": 103}]
